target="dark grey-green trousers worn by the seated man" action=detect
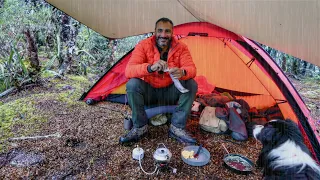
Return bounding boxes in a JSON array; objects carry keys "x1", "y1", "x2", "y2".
[{"x1": 126, "y1": 78, "x2": 198, "y2": 129}]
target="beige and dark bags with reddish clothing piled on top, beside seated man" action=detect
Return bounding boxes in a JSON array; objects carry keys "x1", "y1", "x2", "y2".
[{"x1": 196, "y1": 91, "x2": 250, "y2": 141}]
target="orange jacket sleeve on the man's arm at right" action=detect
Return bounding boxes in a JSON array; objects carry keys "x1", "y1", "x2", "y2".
[{"x1": 180, "y1": 44, "x2": 197, "y2": 80}]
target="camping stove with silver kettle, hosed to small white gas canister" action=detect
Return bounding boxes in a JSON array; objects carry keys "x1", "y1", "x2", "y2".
[{"x1": 132, "y1": 143, "x2": 177, "y2": 175}]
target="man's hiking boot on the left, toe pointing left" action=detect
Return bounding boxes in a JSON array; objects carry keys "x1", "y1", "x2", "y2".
[{"x1": 119, "y1": 125, "x2": 148, "y2": 144}]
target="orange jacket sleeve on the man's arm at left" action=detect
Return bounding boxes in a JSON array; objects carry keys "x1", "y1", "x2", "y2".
[{"x1": 125, "y1": 43, "x2": 150, "y2": 78}]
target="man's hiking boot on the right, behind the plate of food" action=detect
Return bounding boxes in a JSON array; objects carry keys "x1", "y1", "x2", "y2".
[{"x1": 169, "y1": 124, "x2": 197, "y2": 144}]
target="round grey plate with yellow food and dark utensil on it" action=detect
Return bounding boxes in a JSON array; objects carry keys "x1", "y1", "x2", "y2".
[{"x1": 181, "y1": 145, "x2": 210, "y2": 166}]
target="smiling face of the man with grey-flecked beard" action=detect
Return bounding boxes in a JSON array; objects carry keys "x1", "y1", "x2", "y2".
[{"x1": 155, "y1": 21, "x2": 172, "y2": 48}]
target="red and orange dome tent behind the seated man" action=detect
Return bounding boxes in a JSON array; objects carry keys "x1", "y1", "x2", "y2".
[{"x1": 81, "y1": 22, "x2": 320, "y2": 162}]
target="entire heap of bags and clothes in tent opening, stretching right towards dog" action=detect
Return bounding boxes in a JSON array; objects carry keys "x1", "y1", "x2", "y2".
[{"x1": 191, "y1": 88, "x2": 284, "y2": 141}]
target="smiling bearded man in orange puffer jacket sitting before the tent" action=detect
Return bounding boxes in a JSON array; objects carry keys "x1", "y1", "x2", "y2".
[{"x1": 120, "y1": 18, "x2": 198, "y2": 144}]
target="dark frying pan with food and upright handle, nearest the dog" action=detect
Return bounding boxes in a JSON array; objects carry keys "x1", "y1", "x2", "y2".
[{"x1": 221, "y1": 143, "x2": 254, "y2": 174}]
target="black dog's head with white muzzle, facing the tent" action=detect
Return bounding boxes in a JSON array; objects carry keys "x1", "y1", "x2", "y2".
[{"x1": 253, "y1": 119, "x2": 303, "y2": 146}]
